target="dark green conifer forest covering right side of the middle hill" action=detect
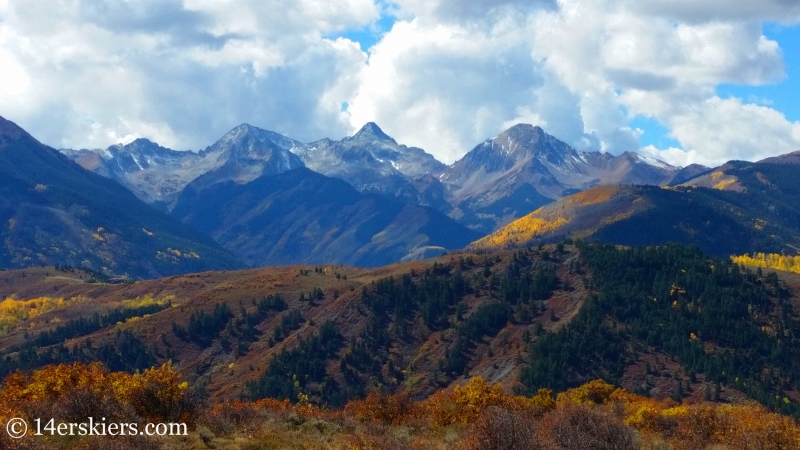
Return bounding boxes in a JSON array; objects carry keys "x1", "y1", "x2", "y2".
[{"x1": 521, "y1": 245, "x2": 800, "y2": 415}]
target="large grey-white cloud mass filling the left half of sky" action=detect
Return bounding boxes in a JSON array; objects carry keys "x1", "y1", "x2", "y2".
[{"x1": 0, "y1": 0, "x2": 378, "y2": 148}]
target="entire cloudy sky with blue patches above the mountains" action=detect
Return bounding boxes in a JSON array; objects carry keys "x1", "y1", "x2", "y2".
[{"x1": 0, "y1": 0, "x2": 800, "y2": 166}]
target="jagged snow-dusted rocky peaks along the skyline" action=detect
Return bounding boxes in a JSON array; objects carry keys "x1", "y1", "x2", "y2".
[{"x1": 62, "y1": 119, "x2": 696, "y2": 234}]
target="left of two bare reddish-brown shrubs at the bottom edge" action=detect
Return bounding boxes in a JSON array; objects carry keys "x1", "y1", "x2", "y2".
[{"x1": 458, "y1": 406, "x2": 543, "y2": 450}]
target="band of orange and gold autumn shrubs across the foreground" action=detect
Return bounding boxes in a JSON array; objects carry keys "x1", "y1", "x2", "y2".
[{"x1": 0, "y1": 363, "x2": 800, "y2": 450}]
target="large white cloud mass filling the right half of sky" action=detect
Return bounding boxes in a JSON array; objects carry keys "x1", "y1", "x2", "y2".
[{"x1": 349, "y1": 0, "x2": 800, "y2": 164}]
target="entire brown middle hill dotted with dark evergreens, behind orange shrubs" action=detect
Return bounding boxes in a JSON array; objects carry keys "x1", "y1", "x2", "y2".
[{"x1": 0, "y1": 241, "x2": 800, "y2": 415}]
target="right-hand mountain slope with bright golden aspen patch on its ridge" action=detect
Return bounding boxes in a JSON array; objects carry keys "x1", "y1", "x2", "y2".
[{"x1": 473, "y1": 155, "x2": 800, "y2": 256}]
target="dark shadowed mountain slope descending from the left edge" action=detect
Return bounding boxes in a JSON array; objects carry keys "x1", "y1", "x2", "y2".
[{"x1": 0, "y1": 118, "x2": 242, "y2": 277}]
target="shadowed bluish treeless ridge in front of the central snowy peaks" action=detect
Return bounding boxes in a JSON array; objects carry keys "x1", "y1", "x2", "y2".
[{"x1": 172, "y1": 169, "x2": 478, "y2": 266}]
